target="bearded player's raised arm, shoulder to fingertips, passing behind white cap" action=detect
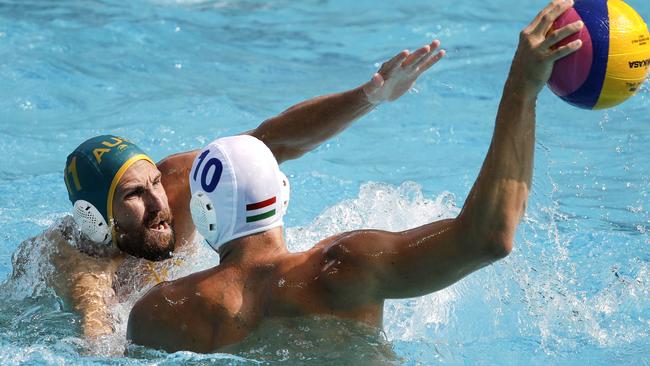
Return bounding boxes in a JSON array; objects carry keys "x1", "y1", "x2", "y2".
[{"x1": 158, "y1": 40, "x2": 445, "y2": 243}]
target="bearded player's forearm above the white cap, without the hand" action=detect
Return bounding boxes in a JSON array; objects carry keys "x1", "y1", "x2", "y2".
[{"x1": 250, "y1": 87, "x2": 374, "y2": 162}]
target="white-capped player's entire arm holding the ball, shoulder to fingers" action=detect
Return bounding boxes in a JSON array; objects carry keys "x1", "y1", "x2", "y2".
[{"x1": 325, "y1": 0, "x2": 582, "y2": 299}]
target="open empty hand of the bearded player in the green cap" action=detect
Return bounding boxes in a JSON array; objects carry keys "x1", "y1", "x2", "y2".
[{"x1": 363, "y1": 40, "x2": 445, "y2": 104}]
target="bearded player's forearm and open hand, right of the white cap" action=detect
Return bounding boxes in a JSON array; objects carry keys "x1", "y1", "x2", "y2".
[{"x1": 247, "y1": 40, "x2": 444, "y2": 163}]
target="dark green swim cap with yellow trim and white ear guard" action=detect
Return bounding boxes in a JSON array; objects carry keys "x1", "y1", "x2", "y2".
[{"x1": 63, "y1": 135, "x2": 156, "y2": 243}]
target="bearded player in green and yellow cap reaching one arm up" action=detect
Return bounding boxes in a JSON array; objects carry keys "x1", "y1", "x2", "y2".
[{"x1": 54, "y1": 41, "x2": 444, "y2": 339}]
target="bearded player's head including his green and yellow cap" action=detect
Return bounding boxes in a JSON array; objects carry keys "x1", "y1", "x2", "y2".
[{"x1": 64, "y1": 135, "x2": 175, "y2": 261}]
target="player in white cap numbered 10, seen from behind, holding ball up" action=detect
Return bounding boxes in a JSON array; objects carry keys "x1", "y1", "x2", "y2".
[{"x1": 127, "y1": 0, "x2": 582, "y2": 352}]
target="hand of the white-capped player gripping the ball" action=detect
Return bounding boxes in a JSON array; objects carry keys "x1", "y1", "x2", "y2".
[{"x1": 510, "y1": 0, "x2": 584, "y2": 96}]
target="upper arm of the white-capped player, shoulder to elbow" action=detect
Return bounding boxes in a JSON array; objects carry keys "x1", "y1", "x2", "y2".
[{"x1": 326, "y1": 219, "x2": 498, "y2": 299}]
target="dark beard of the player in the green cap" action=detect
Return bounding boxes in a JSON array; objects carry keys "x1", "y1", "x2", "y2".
[{"x1": 116, "y1": 211, "x2": 176, "y2": 261}]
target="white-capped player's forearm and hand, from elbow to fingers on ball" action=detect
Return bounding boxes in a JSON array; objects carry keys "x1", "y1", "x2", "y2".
[{"x1": 459, "y1": 0, "x2": 584, "y2": 255}]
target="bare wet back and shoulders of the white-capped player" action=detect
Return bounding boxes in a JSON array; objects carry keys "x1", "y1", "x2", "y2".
[{"x1": 127, "y1": 236, "x2": 383, "y2": 352}]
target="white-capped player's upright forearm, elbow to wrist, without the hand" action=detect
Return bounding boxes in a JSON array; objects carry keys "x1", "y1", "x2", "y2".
[{"x1": 459, "y1": 77, "x2": 537, "y2": 253}]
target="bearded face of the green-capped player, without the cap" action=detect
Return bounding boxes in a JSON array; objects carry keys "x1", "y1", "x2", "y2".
[{"x1": 113, "y1": 161, "x2": 175, "y2": 261}]
